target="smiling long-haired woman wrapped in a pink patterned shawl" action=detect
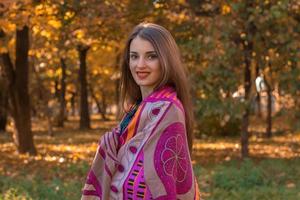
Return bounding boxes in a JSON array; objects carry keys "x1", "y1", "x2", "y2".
[{"x1": 82, "y1": 23, "x2": 199, "y2": 200}]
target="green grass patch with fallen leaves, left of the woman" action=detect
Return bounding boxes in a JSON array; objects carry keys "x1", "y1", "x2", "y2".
[{"x1": 0, "y1": 162, "x2": 89, "y2": 200}]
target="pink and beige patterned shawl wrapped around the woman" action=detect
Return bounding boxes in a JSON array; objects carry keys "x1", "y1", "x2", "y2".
[{"x1": 81, "y1": 87, "x2": 199, "y2": 200}]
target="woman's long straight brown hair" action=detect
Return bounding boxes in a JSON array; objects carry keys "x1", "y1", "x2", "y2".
[{"x1": 121, "y1": 23, "x2": 194, "y2": 150}]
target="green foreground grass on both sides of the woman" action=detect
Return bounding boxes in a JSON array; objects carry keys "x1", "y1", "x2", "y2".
[{"x1": 0, "y1": 159, "x2": 300, "y2": 200}]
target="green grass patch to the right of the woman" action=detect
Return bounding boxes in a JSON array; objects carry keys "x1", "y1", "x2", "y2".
[{"x1": 195, "y1": 158, "x2": 300, "y2": 200}]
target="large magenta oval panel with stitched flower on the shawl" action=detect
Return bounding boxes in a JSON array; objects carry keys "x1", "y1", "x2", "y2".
[{"x1": 154, "y1": 122, "x2": 193, "y2": 195}]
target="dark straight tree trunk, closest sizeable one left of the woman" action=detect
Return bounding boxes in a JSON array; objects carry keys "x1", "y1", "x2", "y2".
[{"x1": 77, "y1": 46, "x2": 90, "y2": 129}]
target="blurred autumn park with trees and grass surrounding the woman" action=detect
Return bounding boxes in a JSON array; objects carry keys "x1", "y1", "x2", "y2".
[{"x1": 0, "y1": 0, "x2": 300, "y2": 200}]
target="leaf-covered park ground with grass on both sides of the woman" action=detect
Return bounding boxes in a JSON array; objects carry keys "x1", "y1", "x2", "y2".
[{"x1": 0, "y1": 120, "x2": 300, "y2": 200}]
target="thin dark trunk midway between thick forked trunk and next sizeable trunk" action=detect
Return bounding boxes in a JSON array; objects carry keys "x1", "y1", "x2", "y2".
[{"x1": 57, "y1": 58, "x2": 67, "y2": 127}]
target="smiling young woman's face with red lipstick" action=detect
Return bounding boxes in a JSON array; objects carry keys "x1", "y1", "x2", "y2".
[{"x1": 129, "y1": 37, "x2": 161, "y2": 94}]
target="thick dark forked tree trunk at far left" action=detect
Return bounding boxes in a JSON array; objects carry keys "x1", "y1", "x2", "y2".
[{"x1": 1, "y1": 26, "x2": 36, "y2": 155}]
